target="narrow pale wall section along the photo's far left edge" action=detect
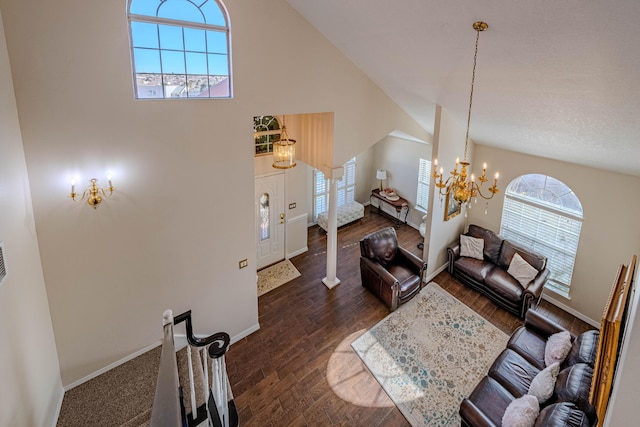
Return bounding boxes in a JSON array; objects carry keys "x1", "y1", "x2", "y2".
[{"x1": 0, "y1": 10, "x2": 63, "y2": 426}]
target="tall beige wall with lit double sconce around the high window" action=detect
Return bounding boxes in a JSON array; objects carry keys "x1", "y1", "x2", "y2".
[{"x1": 0, "y1": 0, "x2": 426, "y2": 385}]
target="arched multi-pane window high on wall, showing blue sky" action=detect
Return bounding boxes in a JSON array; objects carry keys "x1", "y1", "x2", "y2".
[{"x1": 128, "y1": 0, "x2": 232, "y2": 99}]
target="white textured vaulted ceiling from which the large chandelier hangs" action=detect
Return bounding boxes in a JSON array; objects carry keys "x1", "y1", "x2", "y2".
[{"x1": 287, "y1": 0, "x2": 640, "y2": 176}]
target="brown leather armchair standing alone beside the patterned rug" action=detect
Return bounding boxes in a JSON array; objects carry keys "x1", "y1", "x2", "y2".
[{"x1": 360, "y1": 227, "x2": 427, "y2": 311}]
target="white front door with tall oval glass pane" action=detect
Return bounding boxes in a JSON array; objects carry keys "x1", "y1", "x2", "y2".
[{"x1": 255, "y1": 173, "x2": 285, "y2": 269}]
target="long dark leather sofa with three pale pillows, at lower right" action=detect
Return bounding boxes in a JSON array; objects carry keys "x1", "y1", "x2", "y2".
[{"x1": 459, "y1": 310, "x2": 599, "y2": 427}]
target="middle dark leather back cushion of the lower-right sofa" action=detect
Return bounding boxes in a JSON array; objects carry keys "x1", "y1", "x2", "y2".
[{"x1": 554, "y1": 363, "x2": 596, "y2": 421}]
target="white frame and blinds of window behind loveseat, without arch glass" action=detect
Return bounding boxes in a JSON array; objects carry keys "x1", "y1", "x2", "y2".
[{"x1": 500, "y1": 174, "x2": 583, "y2": 299}]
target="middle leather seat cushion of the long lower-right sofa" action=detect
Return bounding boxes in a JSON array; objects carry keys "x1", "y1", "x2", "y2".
[{"x1": 489, "y1": 349, "x2": 540, "y2": 397}]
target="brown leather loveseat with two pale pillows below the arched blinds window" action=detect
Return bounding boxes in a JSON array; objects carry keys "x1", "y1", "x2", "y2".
[{"x1": 447, "y1": 224, "x2": 550, "y2": 318}]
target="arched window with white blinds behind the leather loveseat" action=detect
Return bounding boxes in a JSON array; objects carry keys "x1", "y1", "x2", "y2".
[{"x1": 500, "y1": 174, "x2": 582, "y2": 298}]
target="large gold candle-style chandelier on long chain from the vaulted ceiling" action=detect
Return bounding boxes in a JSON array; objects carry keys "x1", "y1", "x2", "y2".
[{"x1": 431, "y1": 22, "x2": 500, "y2": 206}]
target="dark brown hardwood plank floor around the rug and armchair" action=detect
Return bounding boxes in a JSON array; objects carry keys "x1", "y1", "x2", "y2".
[{"x1": 226, "y1": 208, "x2": 591, "y2": 426}]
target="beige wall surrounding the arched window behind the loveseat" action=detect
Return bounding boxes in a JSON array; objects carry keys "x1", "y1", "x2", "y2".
[{"x1": 468, "y1": 145, "x2": 640, "y2": 323}]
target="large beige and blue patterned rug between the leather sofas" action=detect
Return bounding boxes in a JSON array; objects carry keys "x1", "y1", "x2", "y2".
[{"x1": 351, "y1": 282, "x2": 508, "y2": 426}]
